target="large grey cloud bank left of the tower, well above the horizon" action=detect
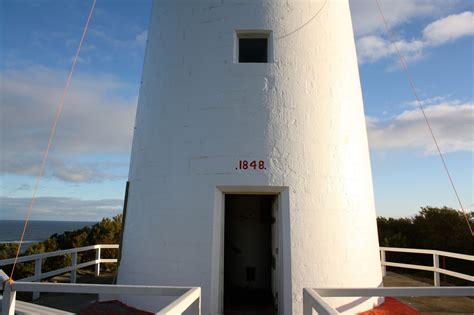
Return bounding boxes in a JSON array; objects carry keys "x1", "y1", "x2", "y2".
[{"x1": 0, "y1": 66, "x2": 136, "y2": 182}]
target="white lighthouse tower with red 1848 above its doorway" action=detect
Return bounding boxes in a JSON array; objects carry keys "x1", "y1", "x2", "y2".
[{"x1": 118, "y1": 0, "x2": 382, "y2": 315}]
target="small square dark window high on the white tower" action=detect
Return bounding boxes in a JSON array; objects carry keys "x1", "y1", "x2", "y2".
[{"x1": 237, "y1": 32, "x2": 269, "y2": 63}]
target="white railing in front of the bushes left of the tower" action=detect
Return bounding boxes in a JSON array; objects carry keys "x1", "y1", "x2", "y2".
[{"x1": 0, "y1": 244, "x2": 119, "y2": 300}]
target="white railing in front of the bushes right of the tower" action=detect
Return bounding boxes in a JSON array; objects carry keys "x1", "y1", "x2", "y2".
[{"x1": 380, "y1": 247, "x2": 474, "y2": 287}]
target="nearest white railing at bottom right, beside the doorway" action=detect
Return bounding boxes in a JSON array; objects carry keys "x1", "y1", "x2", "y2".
[{"x1": 303, "y1": 287, "x2": 474, "y2": 315}]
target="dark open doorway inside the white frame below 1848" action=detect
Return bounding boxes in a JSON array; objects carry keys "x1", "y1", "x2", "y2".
[{"x1": 224, "y1": 194, "x2": 278, "y2": 315}]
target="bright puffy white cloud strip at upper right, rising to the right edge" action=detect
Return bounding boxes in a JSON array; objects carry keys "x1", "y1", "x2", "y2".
[{"x1": 357, "y1": 11, "x2": 474, "y2": 63}]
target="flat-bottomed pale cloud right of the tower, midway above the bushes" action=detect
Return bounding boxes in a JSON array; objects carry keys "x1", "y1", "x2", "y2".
[{"x1": 367, "y1": 101, "x2": 474, "y2": 154}]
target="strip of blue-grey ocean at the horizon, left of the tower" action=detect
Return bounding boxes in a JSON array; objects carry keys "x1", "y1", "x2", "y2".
[{"x1": 0, "y1": 220, "x2": 97, "y2": 244}]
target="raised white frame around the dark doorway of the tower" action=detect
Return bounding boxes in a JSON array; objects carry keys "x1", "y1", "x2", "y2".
[{"x1": 210, "y1": 186, "x2": 292, "y2": 315}]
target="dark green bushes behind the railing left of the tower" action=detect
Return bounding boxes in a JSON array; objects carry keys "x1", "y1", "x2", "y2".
[{"x1": 0, "y1": 214, "x2": 122, "y2": 279}]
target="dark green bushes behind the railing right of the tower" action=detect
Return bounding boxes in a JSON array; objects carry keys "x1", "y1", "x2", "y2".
[{"x1": 377, "y1": 207, "x2": 474, "y2": 284}]
